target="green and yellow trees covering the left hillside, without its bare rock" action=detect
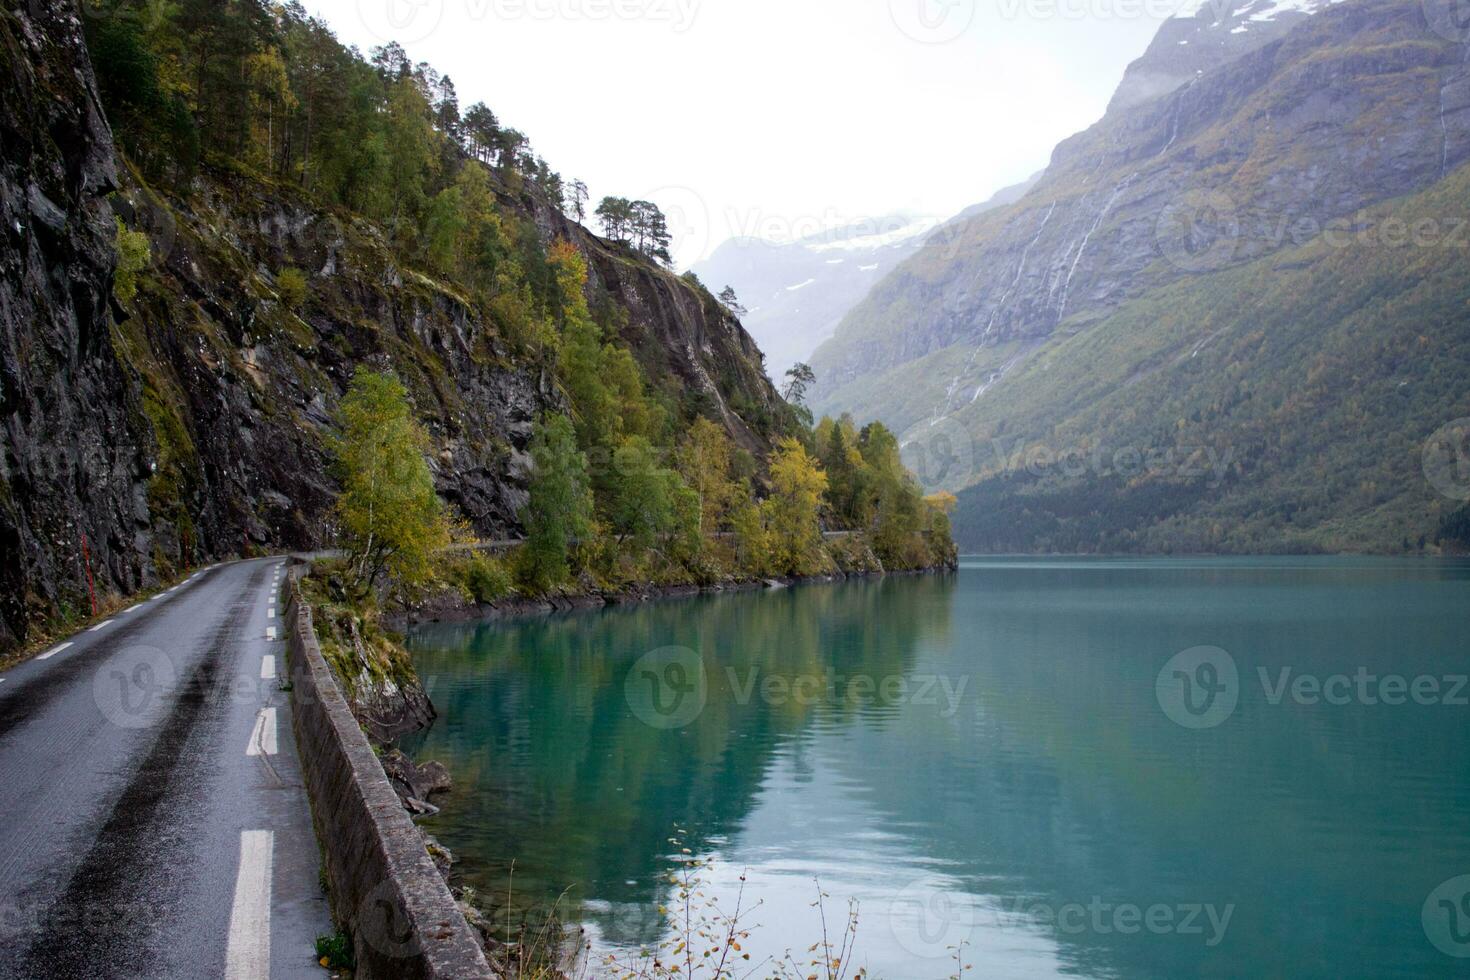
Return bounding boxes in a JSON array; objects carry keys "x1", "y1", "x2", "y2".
[{"x1": 84, "y1": 0, "x2": 953, "y2": 601}]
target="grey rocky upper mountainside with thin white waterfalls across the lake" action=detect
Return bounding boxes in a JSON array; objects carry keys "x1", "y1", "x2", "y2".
[{"x1": 813, "y1": 0, "x2": 1470, "y2": 429}]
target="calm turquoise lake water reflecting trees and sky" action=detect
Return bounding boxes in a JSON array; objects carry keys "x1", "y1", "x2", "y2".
[{"x1": 407, "y1": 558, "x2": 1470, "y2": 977}]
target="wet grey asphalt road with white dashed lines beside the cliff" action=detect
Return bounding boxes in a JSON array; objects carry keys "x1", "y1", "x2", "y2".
[{"x1": 0, "y1": 558, "x2": 331, "y2": 980}]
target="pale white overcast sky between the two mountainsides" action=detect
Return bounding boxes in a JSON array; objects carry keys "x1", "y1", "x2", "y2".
[{"x1": 307, "y1": 0, "x2": 1176, "y2": 267}]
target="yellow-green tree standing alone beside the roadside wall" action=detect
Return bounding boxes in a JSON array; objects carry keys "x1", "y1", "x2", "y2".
[{"x1": 332, "y1": 369, "x2": 448, "y2": 594}]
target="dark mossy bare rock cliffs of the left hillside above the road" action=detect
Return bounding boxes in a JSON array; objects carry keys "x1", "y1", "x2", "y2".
[{"x1": 0, "y1": 1, "x2": 781, "y2": 649}]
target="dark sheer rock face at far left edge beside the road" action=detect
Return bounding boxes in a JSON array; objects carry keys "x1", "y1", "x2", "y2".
[{"x1": 0, "y1": 1, "x2": 147, "y2": 646}]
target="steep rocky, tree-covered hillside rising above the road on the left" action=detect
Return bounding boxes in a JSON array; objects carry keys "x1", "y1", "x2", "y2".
[{"x1": 0, "y1": 0, "x2": 948, "y2": 645}]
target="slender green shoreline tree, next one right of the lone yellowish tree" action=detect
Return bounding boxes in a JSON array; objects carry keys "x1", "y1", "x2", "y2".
[{"x1": 520, "y1": 414, "x2": 592, "y2": 589}]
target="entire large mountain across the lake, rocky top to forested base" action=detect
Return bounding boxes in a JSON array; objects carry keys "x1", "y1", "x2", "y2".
[{"x1": 813, "y1": 0, "x2": 1470, "y2": 552}]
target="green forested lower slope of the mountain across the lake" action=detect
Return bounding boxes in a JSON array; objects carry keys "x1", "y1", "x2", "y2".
[{"x1": 956, "y1": 165, "x2": 1470, "y2": 552}]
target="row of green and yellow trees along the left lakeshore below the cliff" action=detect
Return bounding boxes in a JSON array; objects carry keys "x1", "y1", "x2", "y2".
[{"x1": 324, "y1": 362, "x2": 954, "y2": 614}]
